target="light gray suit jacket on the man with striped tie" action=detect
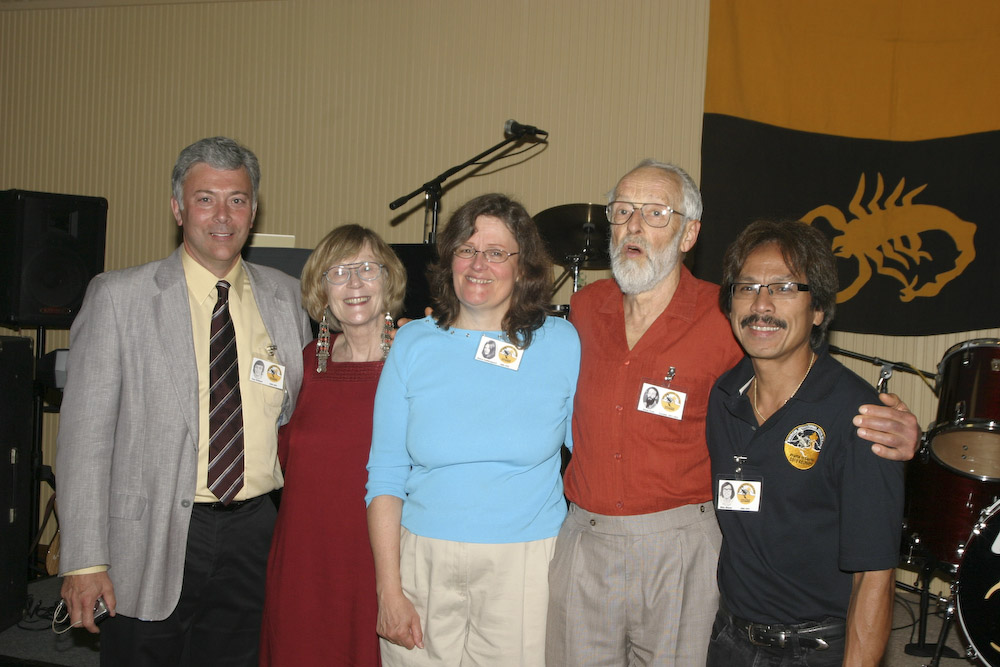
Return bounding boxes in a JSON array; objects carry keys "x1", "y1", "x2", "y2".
[{"x1": 56, "y1": 248, "x2": 312, "y2": 620}]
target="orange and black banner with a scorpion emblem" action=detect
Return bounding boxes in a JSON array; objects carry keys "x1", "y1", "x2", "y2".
[{"x1": 694, "y1": 0, "x2": 1000, "y2": 335}]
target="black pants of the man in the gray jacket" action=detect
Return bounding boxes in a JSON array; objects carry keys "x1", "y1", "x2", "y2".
[{"x1": 101, "y1": 496, "x2": 277, "y2": 667}]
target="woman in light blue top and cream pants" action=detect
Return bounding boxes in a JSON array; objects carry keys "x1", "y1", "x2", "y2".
[{"x1": 365, "y1": 194, "x2": 580, "y2": 667}]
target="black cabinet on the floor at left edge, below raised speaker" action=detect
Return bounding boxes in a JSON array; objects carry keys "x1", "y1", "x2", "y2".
[{"x1": 0, "y1": 336, "x2": 33, "y2": 630}]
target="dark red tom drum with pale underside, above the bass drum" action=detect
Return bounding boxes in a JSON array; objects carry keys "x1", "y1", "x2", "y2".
[{"x1": 929, "y1": 338, "x2": 1000, "y2": 480}]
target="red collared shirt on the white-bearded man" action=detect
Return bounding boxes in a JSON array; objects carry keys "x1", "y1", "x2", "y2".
[{"x1": 565, "y1": 267, "x2": 743, "y2": 515}]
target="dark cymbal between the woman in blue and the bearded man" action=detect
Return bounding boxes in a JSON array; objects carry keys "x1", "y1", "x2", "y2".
[{"x1": 534, "y1": 204, "x2": 611, "y2": 269}]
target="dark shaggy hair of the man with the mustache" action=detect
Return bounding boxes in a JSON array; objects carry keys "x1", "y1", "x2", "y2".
[{"x1": 719, "y1": 219, "x2": 838, "y2": 349}]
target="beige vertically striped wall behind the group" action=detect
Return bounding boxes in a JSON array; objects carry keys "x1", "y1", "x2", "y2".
[{"x1": 0, "y1": 0, "x2": 997, "y2": 548}]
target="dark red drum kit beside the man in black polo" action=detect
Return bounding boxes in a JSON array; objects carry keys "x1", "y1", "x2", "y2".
[{"x1": 903, "y1": 339, "x2": 1000, "y2": 667}]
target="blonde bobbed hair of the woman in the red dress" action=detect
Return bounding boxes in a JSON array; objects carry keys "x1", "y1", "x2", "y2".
[{"x1": 301, "y1": 225, "x2": 406, "y2": 331}]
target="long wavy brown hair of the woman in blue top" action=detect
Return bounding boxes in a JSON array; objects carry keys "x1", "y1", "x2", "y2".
[{"x1": 428, "y1": 193, "x2": 552, "y2": 348}]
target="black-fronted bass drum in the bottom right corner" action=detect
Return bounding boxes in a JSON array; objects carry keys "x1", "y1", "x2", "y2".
[{"x1": 955, "y1": 500, "x2": 1000, "y2": 667}]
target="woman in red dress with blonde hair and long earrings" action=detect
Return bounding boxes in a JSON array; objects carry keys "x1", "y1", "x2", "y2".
[{"x1": 260, "y1": 225, "x2": 406, "y2": 667}]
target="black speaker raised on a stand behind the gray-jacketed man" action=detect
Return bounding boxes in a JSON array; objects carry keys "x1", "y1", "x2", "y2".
[{"x1": 0, "y1": 190, "x2": 108, "y2": 329}]
